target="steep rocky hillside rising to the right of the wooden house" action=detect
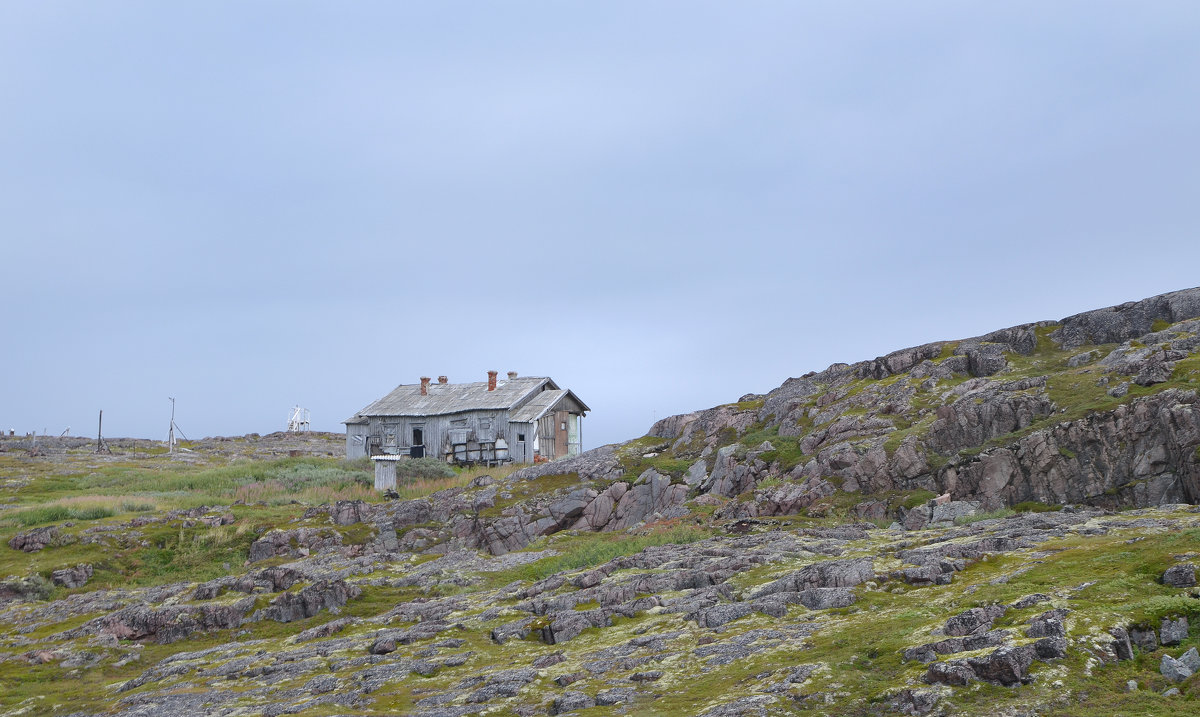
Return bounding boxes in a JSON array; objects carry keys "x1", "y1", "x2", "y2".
[{"x1": 518, "y1": 289, "x2": 1200, "y2": 527}]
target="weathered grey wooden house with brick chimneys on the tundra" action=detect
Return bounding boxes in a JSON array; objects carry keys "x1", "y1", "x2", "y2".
[{"x1": 346, "y1": 370, "x2": 590, "y2": 463}]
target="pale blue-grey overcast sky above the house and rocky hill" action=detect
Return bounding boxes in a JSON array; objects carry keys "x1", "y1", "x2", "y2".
[{"x1": 0, "y1": 0, "x2": 1200, "y2": 447}]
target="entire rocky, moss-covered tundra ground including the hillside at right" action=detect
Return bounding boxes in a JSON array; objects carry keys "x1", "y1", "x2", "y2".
[{"x1": 0, "y1": 290, "x2": 1200, "y2": 717}]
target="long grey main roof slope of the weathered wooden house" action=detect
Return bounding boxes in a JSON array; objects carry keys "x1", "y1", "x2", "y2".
[{"x1": 344, "y1": 376, "x2": 558, "y2": 423}]
